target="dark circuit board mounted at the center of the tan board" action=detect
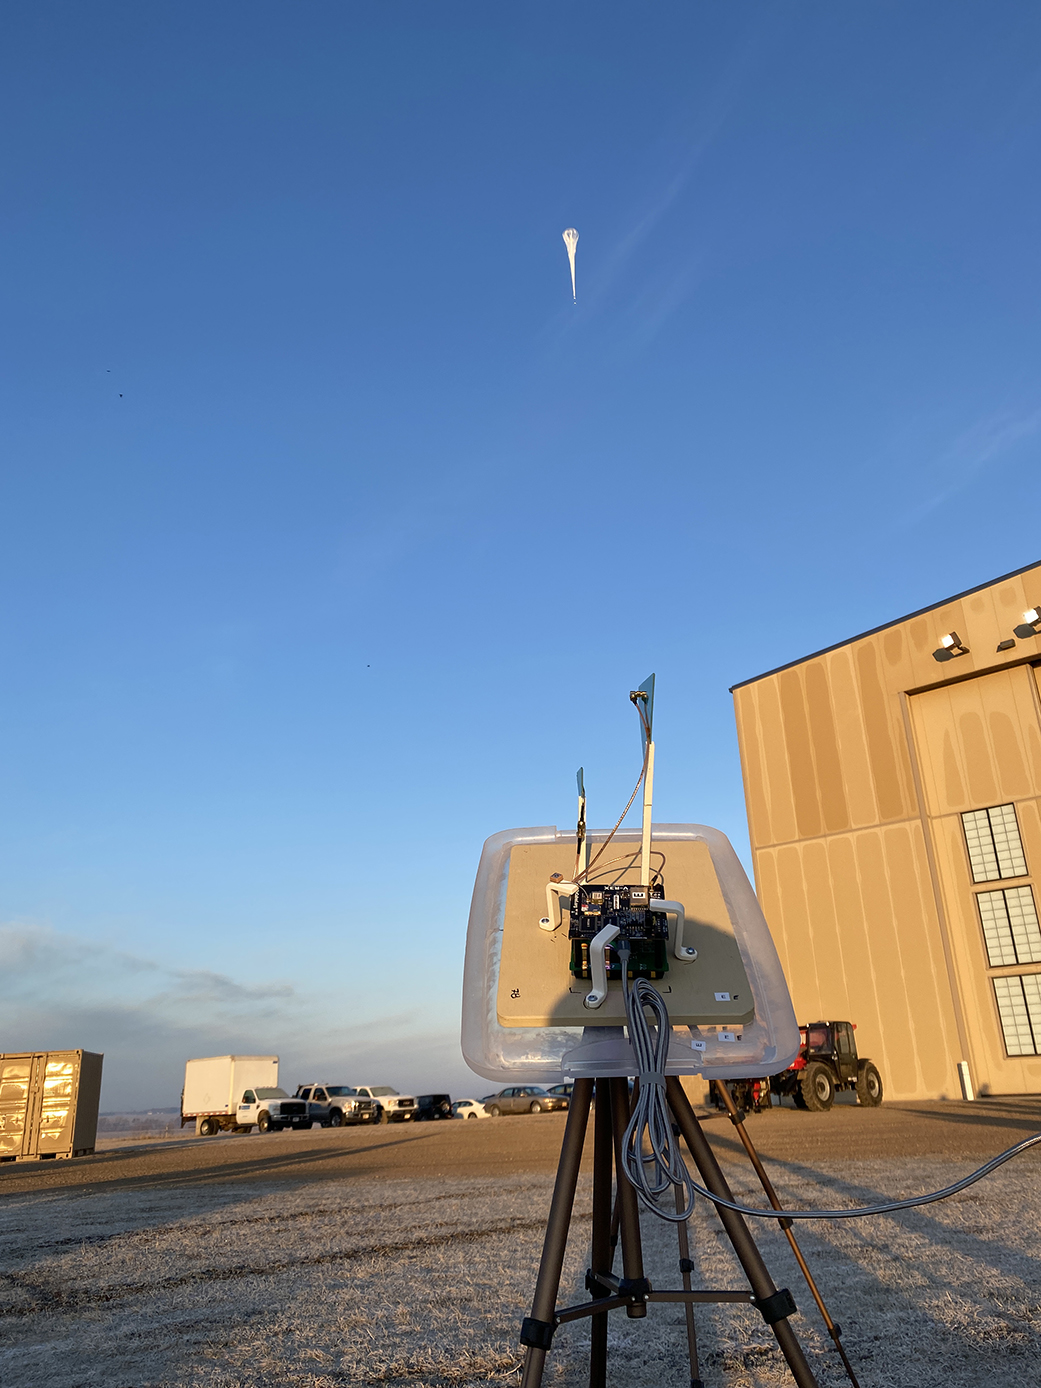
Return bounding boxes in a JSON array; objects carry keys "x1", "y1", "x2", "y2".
[{"x1": 568, "y1": 883, "x2": 669, "y2": 981}]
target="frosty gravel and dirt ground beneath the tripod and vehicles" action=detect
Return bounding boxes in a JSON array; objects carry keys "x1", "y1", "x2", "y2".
[{"x1": 0, "y1": 1099, "x2": 1041, "y2": 1388}]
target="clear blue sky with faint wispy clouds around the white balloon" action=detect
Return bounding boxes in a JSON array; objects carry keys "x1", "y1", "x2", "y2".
[{"x1": 0, "y1": 0, "x2": 1041, "y2": 1108}]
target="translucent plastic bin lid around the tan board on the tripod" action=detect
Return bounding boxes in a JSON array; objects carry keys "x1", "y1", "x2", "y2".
[{"x1": 462, "y1": 824, "x2": 799, "y2": 1084}]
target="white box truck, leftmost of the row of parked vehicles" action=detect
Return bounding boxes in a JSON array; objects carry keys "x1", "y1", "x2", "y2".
[{"x1": 180, "y1": 1055, "x2": 311, "y2": 1137}]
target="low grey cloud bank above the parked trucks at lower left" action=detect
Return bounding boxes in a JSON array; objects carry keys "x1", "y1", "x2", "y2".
[{"x1": 0, "y1": 924, "x2": 480, "y2": 1113}]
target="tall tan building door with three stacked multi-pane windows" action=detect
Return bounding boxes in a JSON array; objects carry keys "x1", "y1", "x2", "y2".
[{"x1": 909, "y1": 665, "x2": 1041, "y2": 1094}]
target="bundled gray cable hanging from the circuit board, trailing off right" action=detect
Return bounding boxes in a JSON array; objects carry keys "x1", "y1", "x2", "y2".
[{"x1": 618, "y1": 940, "x2": 1041, "y2": 1224}]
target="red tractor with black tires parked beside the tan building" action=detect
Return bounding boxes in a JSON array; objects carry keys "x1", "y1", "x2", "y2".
[{"x1": 713, "y1": 1022, "x2": 881, "y2": 1113}]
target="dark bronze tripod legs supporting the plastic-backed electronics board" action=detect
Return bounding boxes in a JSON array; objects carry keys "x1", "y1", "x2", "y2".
[{"x1": 521, "y1": 1076, "x2": 818, "y2": 1388}]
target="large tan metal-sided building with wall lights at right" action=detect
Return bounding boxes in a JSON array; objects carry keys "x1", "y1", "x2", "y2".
[{"x1": 731, "y1": 564, "x2": 1041, "y2": 1099}]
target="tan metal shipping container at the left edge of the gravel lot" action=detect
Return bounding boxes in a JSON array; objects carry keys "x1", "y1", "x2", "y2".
[{"x1": 0, "y1": 1051, "x2": 104, "y2": 1162}]
